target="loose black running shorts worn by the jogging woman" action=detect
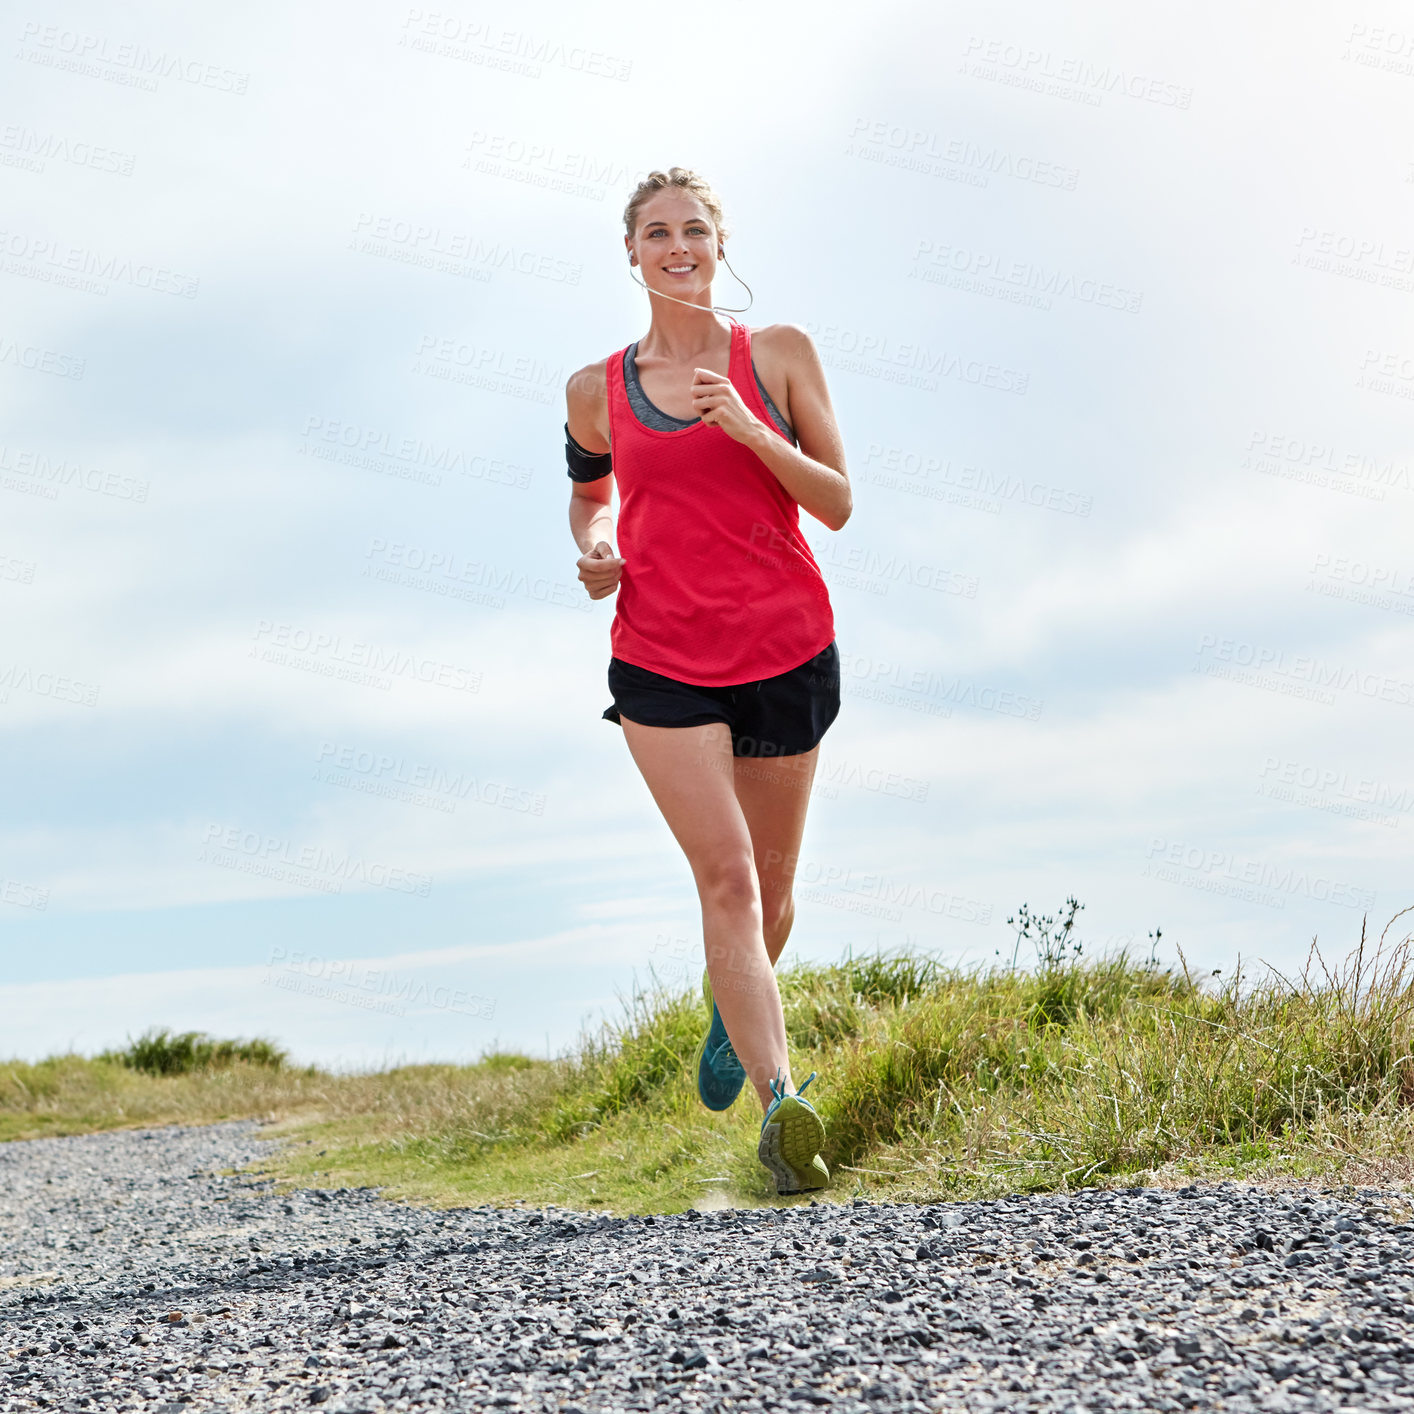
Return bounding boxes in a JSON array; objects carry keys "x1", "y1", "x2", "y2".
[{"x1": 604, "y1": 642, "x2": 840, "y2": 756}]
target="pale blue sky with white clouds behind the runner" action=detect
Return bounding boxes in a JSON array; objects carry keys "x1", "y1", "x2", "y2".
[{"x1": 0, "y1": 0, "x2": 1414, "y2": 1065}]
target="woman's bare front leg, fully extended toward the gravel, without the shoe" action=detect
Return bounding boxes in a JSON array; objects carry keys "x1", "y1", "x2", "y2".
[{"x1": 621, "y1": 717, "x2": 795, "y2": 1110}]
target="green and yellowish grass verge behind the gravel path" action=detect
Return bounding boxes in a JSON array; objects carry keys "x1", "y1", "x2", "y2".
[{"x1": 0, "y1": 899, "x2": 1414, "y2": 1212}]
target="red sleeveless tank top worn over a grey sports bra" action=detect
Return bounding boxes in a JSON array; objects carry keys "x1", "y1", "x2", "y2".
[{"x1": 608, "y1": 320, "x2": 834, "y2": 687}]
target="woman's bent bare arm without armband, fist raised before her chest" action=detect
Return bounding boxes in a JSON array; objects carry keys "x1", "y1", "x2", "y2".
[{"x1": 693, "y1": 324, "x2": 854, "y2": 530}]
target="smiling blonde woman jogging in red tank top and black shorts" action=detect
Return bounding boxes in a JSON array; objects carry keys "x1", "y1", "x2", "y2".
[{"x1": 564, "y1": 167, "x2": 853, "y2": 1193}]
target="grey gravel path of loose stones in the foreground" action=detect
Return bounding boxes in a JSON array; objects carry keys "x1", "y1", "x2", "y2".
[{"x1": 0, "y1": 1124, "x2": 1414, "y2": 1414}]
